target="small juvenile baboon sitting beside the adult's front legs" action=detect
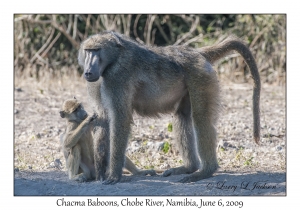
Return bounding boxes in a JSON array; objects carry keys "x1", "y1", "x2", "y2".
[{"x1": 59, "y1": 98, "x2": 95, "y2": 181}]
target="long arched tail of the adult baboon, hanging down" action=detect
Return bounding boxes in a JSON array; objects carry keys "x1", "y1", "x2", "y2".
[{"x1": 200, "y1": 37, "x2": 261, "y2": 144}]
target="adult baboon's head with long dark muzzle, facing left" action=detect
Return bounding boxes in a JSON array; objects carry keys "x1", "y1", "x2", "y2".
[{"x1": 78, "y1": 32, "x2": 122, "y2": 82}]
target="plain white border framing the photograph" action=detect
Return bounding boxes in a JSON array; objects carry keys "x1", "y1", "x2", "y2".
[{"x1": 0, "y1": 0, "x2": 300, "y2": 209}]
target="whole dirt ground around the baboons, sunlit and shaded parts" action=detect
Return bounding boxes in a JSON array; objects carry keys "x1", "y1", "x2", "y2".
[{"x1": 14, "y1": 78, "x2": 286, "y2": 196}]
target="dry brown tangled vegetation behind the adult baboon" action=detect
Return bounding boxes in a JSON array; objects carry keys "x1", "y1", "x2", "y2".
[{"x1": 14, "y1": 14, "x2": 286, "y2": 85}]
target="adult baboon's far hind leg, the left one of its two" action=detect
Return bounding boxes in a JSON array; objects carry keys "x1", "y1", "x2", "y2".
[{"x1": 163, "y1": 94, "x2": 200, "y2": 176}]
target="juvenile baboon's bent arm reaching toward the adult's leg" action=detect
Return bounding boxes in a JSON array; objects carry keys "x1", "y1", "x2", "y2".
[{"x1": 63, "y1": 120, "x2": 89, "y2": 149}]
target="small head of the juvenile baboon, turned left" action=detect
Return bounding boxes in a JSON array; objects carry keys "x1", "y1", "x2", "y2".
[{"x1": 59, "y1": 97, "x2": 87, "y2": 122}]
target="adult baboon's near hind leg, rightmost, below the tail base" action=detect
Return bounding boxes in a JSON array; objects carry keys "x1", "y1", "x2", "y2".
[{"x1": 180, "y1": 72, "x2": 219, "y2": 182}]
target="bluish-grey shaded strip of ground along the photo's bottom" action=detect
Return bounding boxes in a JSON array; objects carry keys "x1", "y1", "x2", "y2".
[{"x1": 14, "y1": 171, "x2": 286, "y2": 196}]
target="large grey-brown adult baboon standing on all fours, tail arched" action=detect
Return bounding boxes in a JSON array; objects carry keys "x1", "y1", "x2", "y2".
[{"x1": 78, "y1": 32, "x2": 260, "y2": 184}]
